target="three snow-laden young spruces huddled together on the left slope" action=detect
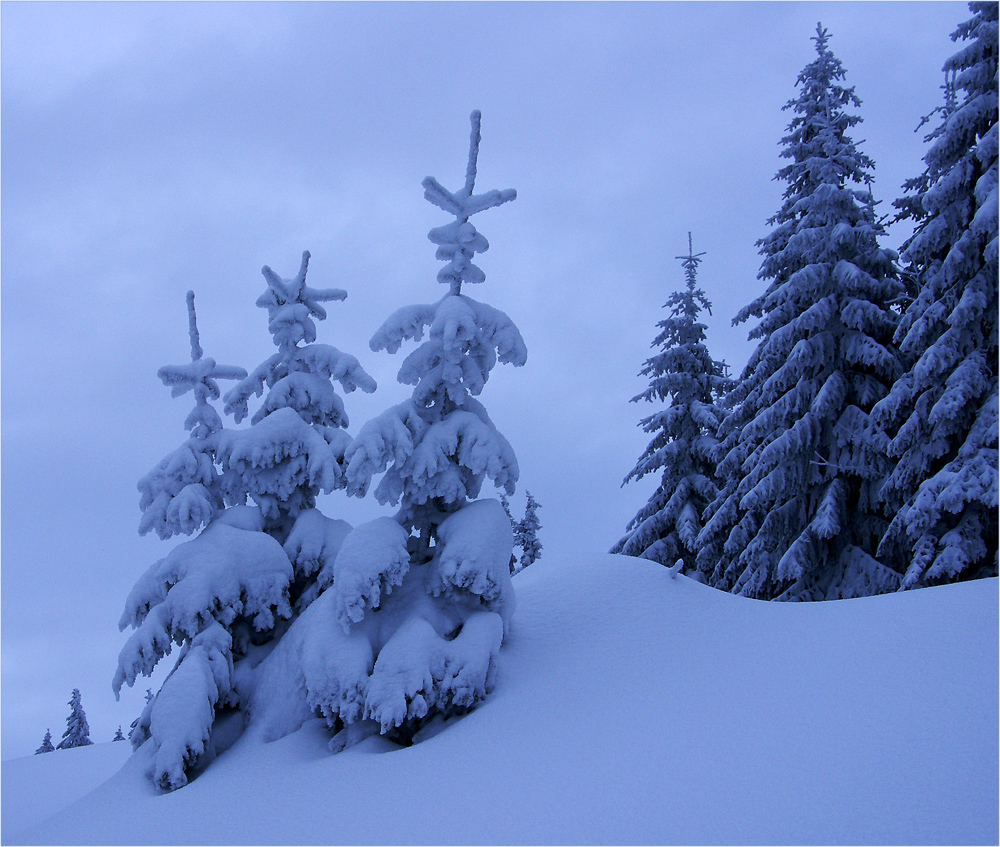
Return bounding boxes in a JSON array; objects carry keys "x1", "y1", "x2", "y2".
[{"x1": 114, "y1": 112, "x2": 537, "y2": 790}]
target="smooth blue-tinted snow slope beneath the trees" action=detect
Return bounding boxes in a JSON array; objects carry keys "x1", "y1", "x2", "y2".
[{"x1": 3, "y1": 555, "x2": 1000, "y2": 844}]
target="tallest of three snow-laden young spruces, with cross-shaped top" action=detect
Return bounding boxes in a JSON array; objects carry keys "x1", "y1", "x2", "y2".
[{"x1": 255, "y1": 112, "x2": 527, "y2": 750}]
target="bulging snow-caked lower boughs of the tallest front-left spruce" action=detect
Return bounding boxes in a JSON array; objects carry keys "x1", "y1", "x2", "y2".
[{"x1": 250, "y1": 500, "x2": 515, "y2": 749}]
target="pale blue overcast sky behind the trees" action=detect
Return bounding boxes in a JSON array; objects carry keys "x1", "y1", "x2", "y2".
[{"x1": 0, "y1": 2, "x2": 970, "y2": 758}]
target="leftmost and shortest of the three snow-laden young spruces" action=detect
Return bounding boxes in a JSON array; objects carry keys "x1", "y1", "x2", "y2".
[{"x1": 113, "y1": 292, "x2": 274, "y2": 789}]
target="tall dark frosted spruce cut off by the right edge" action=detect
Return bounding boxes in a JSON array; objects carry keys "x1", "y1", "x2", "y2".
[{"x1": 874, "y1": 3, "x2": 1000, "y2": 588}]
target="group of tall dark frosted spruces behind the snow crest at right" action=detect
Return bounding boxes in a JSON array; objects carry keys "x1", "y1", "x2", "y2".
[{"x1": 612, "y1": 2, "x2": 998, "y2": 600}]
